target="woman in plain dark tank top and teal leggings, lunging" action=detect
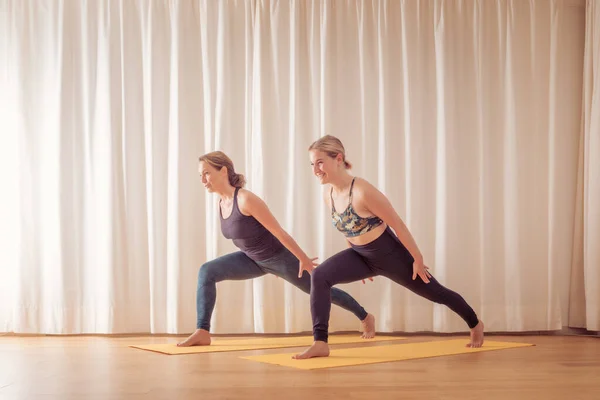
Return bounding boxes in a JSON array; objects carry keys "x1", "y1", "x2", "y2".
[{"x1": 178, "y1": 151, "x2": 375, "y2": 346}]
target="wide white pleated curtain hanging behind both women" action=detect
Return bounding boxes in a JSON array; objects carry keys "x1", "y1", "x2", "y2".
[{"x1": 0, "y1": 0, "x2": 600, "y2": 333}]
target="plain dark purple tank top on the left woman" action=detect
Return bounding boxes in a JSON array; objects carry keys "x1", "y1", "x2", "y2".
[{"x1": 219, "y1": 188, "x2": 285, "y2": 261}]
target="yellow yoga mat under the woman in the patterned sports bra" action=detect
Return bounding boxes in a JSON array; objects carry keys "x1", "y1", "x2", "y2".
[{"x1": 240, "y1": 339, "x2": 533, "y2": 369}]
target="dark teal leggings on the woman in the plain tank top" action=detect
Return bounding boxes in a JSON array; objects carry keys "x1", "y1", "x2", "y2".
[{"x1": 196, "y1": 248, "x2": 367, "y2": 331}]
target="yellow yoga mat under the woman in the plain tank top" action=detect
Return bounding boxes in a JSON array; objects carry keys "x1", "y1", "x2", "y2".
[{"x1": 129, "y1": 334, "x2": 405, "y2": 355}]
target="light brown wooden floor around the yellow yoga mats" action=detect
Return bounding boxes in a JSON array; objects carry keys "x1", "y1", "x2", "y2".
[{"x1": 0, "y1": 336, "x2": 600, "y2": 400}]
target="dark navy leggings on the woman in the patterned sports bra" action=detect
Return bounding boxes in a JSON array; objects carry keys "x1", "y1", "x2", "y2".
[{"x1": 310, "y1": 227, "x2": 479, "y2": 342}]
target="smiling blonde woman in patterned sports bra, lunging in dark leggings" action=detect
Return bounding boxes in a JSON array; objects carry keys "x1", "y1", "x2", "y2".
[{"x1": 294, "y1": 135, "x2": 483, "y2": 359}]
